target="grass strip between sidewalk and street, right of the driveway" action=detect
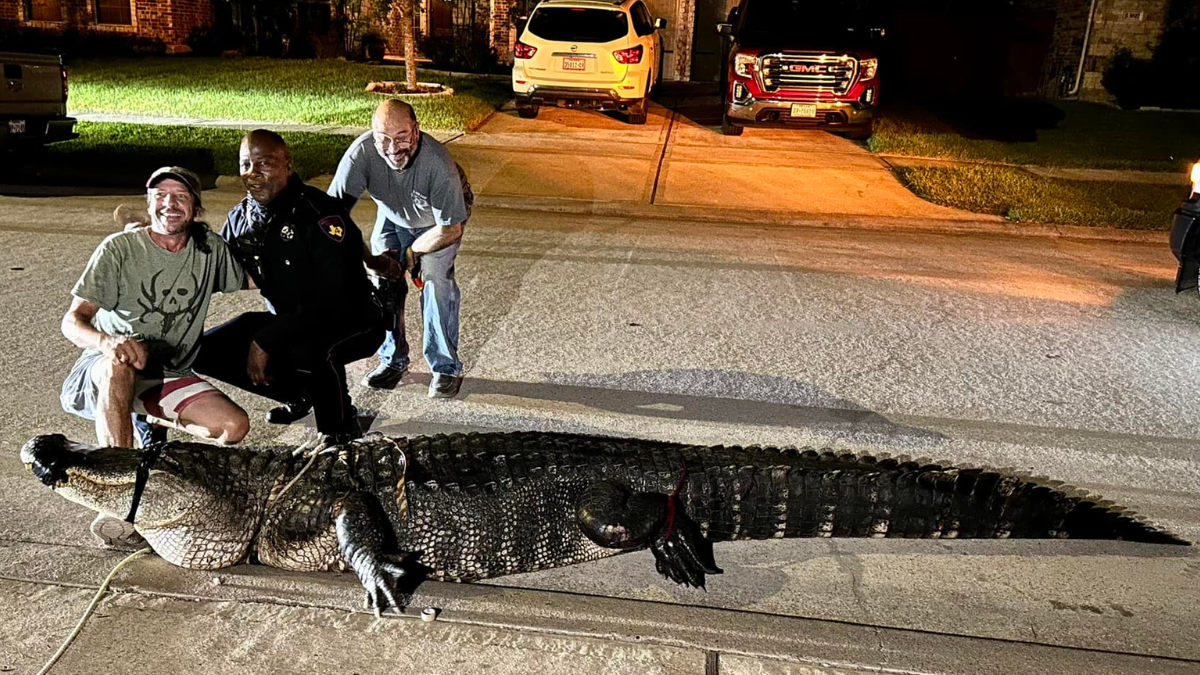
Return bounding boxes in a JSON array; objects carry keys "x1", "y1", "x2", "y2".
[{"x1": 895, "y1": 166, "x2": 1187, "y2": 229}]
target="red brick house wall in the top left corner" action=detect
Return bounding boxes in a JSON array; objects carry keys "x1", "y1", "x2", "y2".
[{"x1": 0, "y1": 0, "x2": 215, "y2": 53}]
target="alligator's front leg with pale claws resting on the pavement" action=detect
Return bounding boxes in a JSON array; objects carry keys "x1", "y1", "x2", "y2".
[{"x1": 336, "y1": 492, "x2": 407, "y2": 617}]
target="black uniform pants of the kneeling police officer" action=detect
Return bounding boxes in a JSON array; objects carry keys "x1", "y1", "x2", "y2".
[{"x1": 194, "y1": 312, "x2": 384, "y2": 434}]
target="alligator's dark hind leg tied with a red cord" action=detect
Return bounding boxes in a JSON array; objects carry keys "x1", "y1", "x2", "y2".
[{"x1": 575, "y1": 480, "x2": 721, "y2": 589}]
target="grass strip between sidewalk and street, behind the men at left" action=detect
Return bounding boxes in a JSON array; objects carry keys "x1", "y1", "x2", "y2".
[{"x1": 47, "y1": 123, "x2": 354, "y2": 179}]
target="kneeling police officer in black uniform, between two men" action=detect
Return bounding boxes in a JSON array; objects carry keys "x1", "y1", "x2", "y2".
[{"x1": 196, "y1": 129, "x2": 384, "y2": 442}]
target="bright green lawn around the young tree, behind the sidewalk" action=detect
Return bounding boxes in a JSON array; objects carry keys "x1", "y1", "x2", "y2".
[{"x1": 68, "y1": 56, "x2": 511, "y2": 131}]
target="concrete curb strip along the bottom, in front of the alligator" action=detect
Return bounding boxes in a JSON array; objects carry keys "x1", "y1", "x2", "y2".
[{"x1": 9, "y1": 540, "x2": 1196, "y2": 675}]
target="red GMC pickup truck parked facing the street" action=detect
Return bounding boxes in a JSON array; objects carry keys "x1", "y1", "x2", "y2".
[{"x1": 716, "y1": 0, "x2": 886, "y2": 139}]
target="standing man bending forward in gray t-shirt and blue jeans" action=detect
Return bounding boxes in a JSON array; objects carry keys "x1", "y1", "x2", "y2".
[{"x1": 329, "y1": 100, "x2": 473, "y2": 398}]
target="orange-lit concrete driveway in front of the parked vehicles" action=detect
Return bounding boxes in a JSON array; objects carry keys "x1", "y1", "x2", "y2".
[{"x1": 450, "y1": 87, "x2": 988, "y2": 221}]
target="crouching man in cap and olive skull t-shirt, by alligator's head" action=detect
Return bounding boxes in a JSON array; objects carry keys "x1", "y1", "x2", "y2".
[{"x1": 60, "y1": 167, "x2": 250, "y2": 546}]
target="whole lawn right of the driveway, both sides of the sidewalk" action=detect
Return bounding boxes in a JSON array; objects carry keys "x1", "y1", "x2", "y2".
[{"x1": 868, "y1": 100, "x2": 1200, "y2": 229}]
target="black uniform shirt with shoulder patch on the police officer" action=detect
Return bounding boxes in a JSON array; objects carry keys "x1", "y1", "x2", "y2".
[{"x1": 221, "y1": 175, "x2": 379, "y2": 353}]
